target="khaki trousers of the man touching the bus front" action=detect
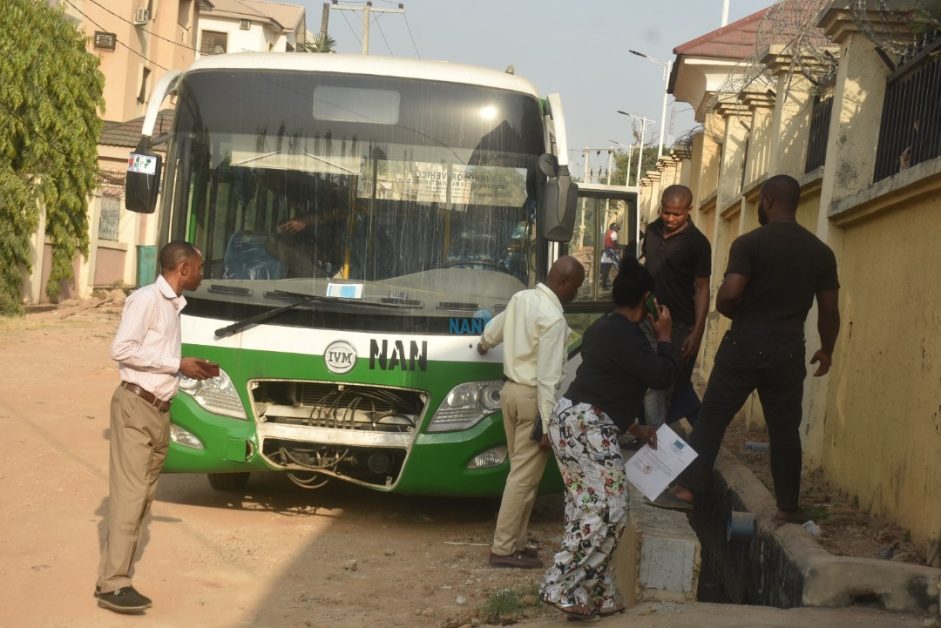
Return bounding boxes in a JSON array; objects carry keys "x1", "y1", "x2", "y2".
[{"x1": 491, "y1": 382, "x2": 550, "y2": 556}]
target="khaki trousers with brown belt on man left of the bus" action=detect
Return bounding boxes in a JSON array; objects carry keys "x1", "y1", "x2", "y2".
[{"x1": 98, "y1": 386, "x2": 170, "y2": 593}]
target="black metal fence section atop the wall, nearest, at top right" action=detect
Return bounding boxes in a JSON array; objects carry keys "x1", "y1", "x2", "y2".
[{"x1": 873, "y1": 31, "x2": 941, "y2": 181}]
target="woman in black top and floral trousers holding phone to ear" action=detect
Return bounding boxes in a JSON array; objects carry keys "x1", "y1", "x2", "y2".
[{"x1": 541, "y1": 257, "x2": 676, "y2": 620}]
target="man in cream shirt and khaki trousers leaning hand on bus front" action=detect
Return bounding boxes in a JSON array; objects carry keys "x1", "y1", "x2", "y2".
[{"x1": 477, "y1": 256, "x2": 585, "y2": 569}]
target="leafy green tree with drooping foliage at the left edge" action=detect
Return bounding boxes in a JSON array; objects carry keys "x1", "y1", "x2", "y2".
[{"x1": 0, "y1": 0, "x2": 104, "y2": 315}]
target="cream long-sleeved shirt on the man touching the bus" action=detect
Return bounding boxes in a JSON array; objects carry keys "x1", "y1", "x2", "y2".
[{"x1": 480, "y1": 284, "x2": 571, "y2": 434}]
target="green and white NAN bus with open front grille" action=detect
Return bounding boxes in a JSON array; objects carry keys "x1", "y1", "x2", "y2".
[{"x1": 125, "y1": 53, "x2": 577, "y2": 496}]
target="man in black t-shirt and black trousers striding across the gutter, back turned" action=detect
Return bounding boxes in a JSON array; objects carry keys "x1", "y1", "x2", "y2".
[{"x1": 654, "y1": 175, "x2": 840, "y2": 523}]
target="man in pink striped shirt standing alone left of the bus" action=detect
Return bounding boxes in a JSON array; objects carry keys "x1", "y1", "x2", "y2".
[{"x1": 95, "y1": 242, "x2": 218, "y2": 613}]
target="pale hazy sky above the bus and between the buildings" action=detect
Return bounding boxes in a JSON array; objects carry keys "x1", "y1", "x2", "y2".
[{"x1": 298, "y1": 0, "x2": 774, "y2": 175}]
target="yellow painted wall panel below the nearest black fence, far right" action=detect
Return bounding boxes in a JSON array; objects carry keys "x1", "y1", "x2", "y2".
[{"x1": 820, "y1": 184, "x2": 941, "y2": 541}]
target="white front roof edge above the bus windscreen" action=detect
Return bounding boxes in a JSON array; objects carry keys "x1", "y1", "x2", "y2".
[{"x1": 186, "y1": 52, "x2": 539, "y2": 98}]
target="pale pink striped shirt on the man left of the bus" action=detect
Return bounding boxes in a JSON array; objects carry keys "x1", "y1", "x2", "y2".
[{"x1": 111, "y1": 276, "x2": 186, "y2": 401}]
